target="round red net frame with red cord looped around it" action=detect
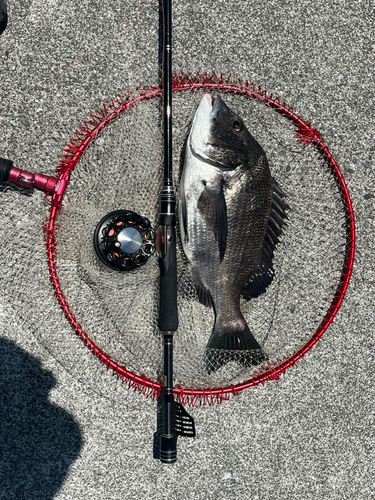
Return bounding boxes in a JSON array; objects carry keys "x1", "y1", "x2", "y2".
[{"x1": 44, "y1": 73, "x2": 355, "y2": 406}]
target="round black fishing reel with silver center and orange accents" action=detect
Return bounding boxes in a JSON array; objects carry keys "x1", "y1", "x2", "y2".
[{"x1": 94, "y1": 210, "x2": 155, "y2": 271}]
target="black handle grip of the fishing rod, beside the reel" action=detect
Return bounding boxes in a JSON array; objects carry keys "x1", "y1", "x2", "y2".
[{"x1": 159, "y1": 225, "x2": 178, "y2": 332}]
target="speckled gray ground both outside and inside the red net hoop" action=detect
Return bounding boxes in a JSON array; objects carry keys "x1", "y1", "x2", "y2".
[{"x1": 0, "y1": 0, "x2": 375, "y2": 500}]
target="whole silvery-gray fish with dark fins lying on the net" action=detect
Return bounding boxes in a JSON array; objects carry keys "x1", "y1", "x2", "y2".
[{"x1": 178, "y1": 93, "x2": 289, "y2": 373}]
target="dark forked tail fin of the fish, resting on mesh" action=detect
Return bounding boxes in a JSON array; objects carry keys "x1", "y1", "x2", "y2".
[{"x1": 206, "y1": 320, "x2": 267, "y2": 373}]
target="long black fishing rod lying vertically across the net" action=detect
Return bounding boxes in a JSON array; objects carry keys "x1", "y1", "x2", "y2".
[{"x1": 159, "y1": 0, "x2": 178, "y2": 463}]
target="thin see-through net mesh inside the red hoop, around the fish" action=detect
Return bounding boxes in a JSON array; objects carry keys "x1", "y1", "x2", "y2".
[{"x1": 51, "y1": 81, "x2": 348, "y2": 389}]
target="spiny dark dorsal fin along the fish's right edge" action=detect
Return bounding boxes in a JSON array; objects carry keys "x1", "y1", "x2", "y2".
[{"x1": 242, "y1": 181, "x2": 289, "y2": 300}]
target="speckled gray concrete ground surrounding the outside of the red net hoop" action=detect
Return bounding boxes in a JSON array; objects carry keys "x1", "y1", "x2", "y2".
[{"x1": 0, "y1": 0, "x2": 375, "y2": 500}]
